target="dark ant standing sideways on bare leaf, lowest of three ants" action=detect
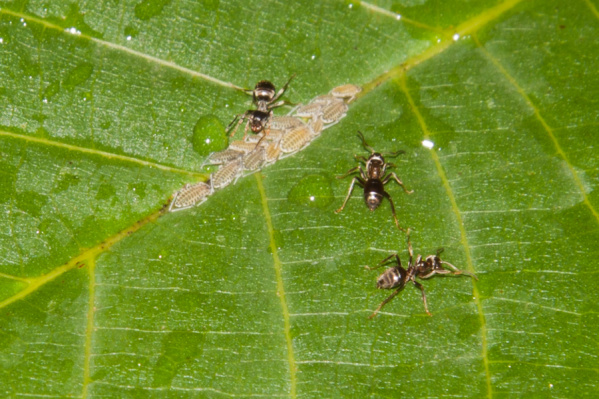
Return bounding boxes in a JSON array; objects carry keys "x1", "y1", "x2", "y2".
[{"x1": 366, "y1": 230, "x2": 478, "y2": 319}]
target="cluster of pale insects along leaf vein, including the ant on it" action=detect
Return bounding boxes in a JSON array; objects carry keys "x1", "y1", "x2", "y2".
[{"x1": 169, "y1": 77, "x2": 362, "y2": 212}]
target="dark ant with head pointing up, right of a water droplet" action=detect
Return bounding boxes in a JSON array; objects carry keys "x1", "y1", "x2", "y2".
[{"x1": 335, "y1": 131, "x2": 414, "y2": 230}]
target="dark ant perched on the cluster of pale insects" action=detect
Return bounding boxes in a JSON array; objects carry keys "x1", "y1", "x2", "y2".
[{"x1": 227, "y1": 75, "x2": 295, "y2": 138}]
